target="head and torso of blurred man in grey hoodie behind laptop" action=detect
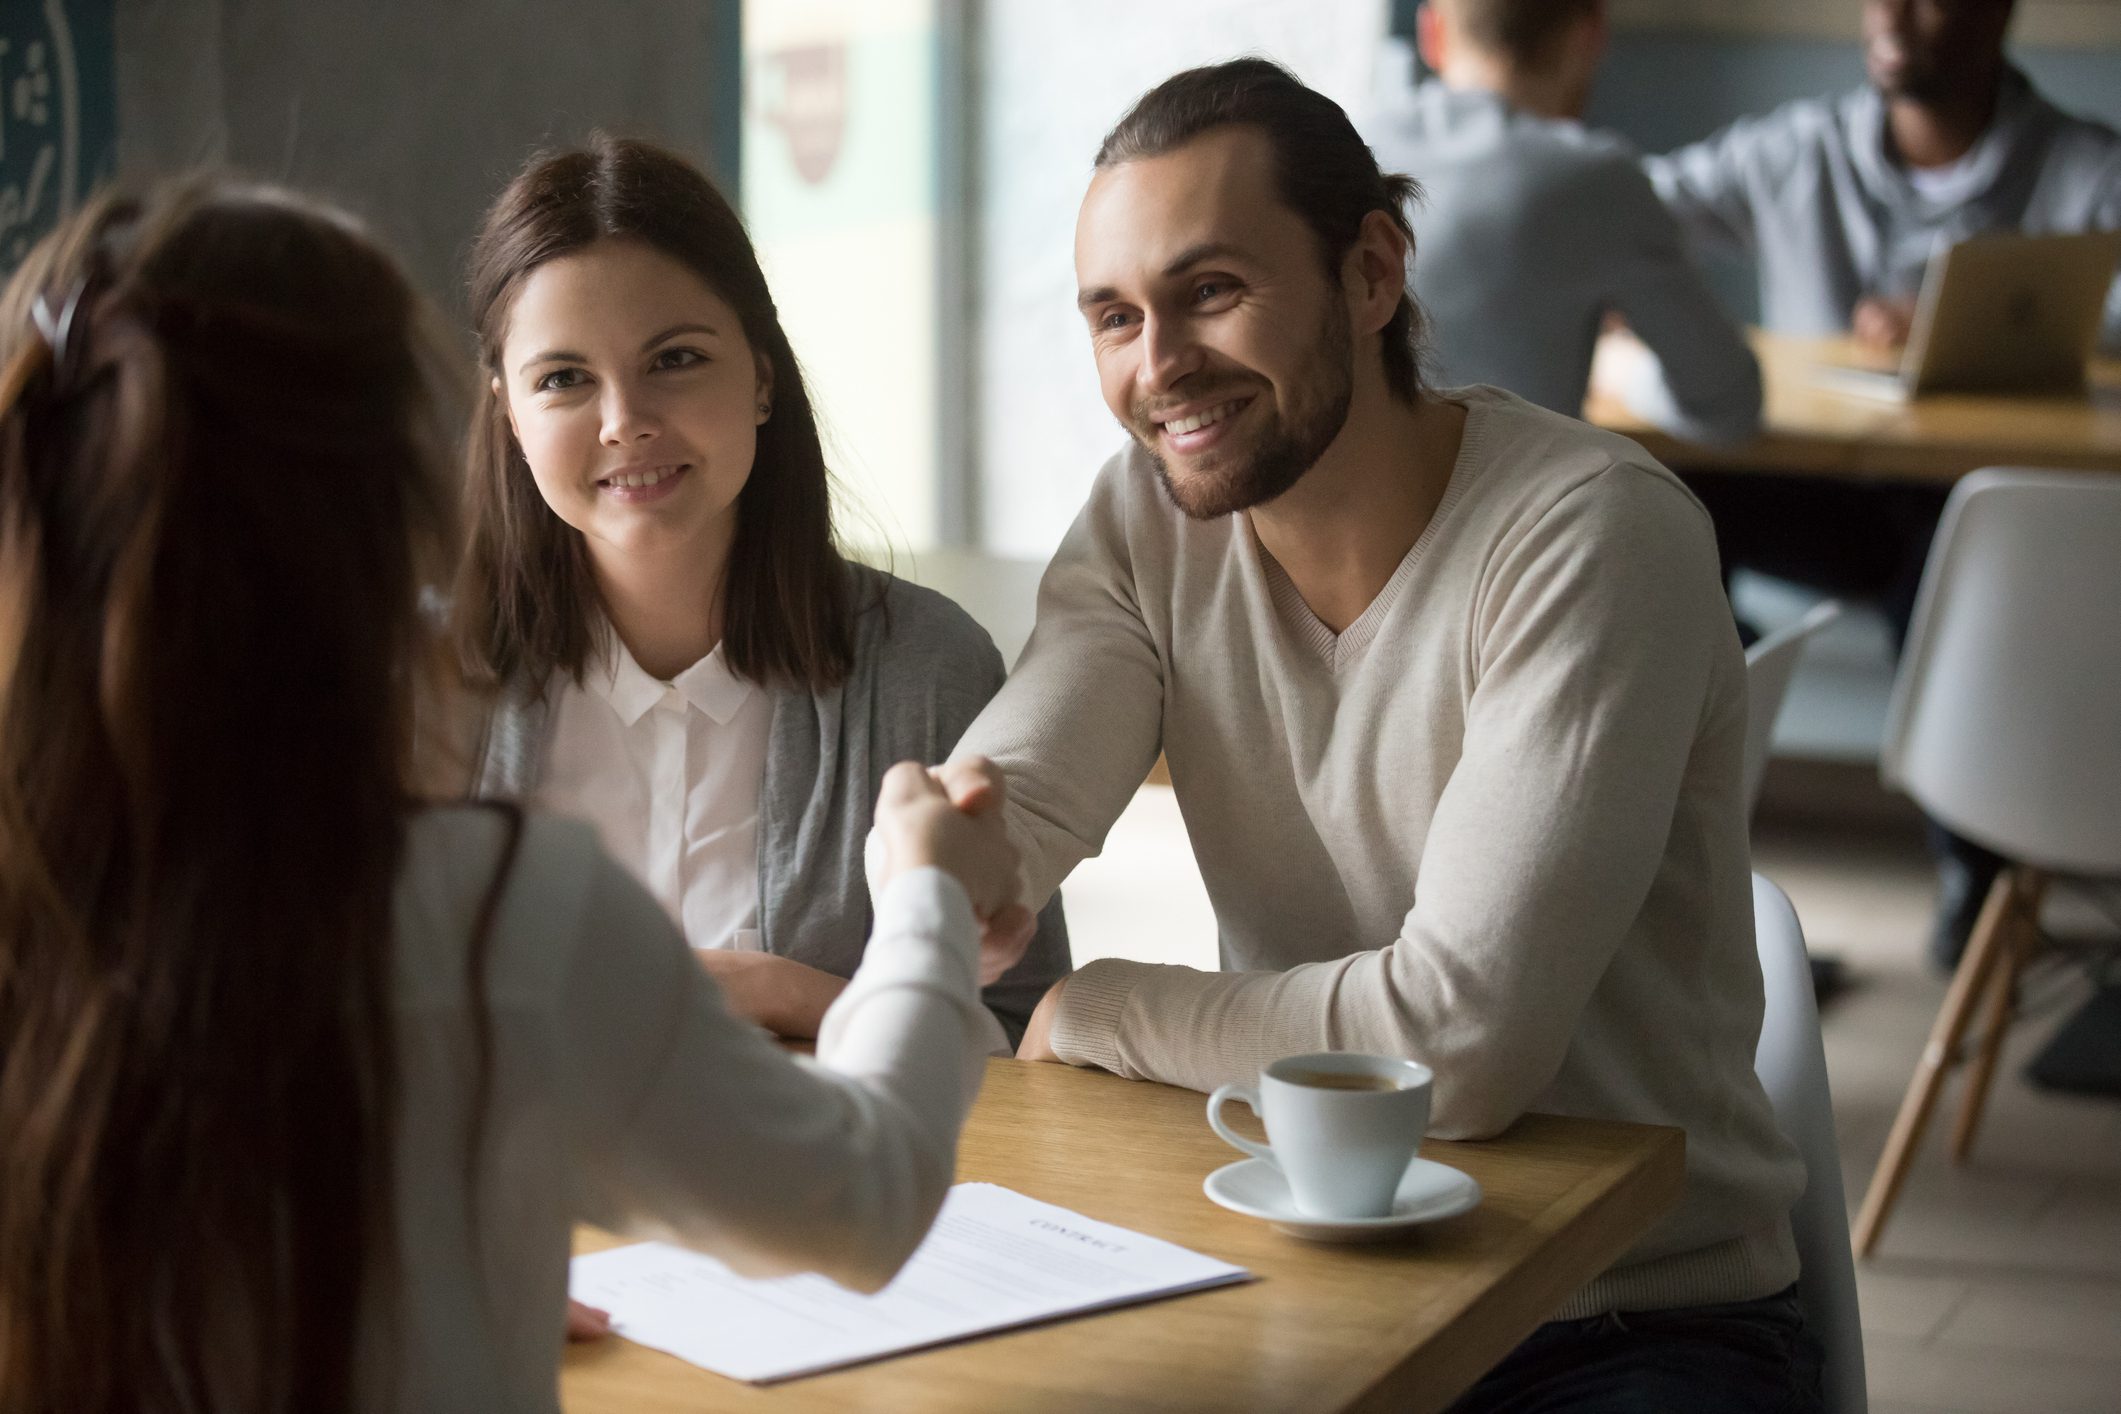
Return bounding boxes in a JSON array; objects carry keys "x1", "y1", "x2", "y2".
[{"x1": 1648, "y1": 0, "x2": 2121, "y2": 352}]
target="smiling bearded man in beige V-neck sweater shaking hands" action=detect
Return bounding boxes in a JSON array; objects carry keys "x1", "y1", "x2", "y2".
[{"x1": 959, "y1": 59, "x2": 1816, "y2": 1410}]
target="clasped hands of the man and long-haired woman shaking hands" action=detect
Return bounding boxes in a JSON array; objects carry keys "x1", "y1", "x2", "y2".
[{"x1": 867, "y1": 757, "x2": 1037, "y2": 986}]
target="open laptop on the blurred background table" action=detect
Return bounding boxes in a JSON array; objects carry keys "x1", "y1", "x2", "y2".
[{"x1": 1816, "y1": 231, "x2": 2121, "y2": 399}]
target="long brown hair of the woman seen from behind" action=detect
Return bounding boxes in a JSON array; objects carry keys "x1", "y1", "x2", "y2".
[{"x1": 0, "y1": 184, "x2": 462, "y2": 1414}]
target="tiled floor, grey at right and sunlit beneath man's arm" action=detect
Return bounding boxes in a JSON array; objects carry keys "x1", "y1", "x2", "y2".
[{"x1": 1067, "y1": 786, "x2": 2121, "y2": 1414}]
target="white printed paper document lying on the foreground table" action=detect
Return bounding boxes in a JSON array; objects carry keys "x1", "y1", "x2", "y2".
[{"x1": 568, "y1": 1183, "x2": 1251, "y2": 1382}]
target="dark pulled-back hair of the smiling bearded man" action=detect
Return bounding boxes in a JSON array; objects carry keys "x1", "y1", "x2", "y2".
[{"x1": 1097, "y1": 57, "x2": 1421, "y2": 403}]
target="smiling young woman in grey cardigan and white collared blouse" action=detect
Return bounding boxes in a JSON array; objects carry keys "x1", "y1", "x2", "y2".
[{"x1": 456, "y1": 138, "x2": 1069, "y2": 1047}]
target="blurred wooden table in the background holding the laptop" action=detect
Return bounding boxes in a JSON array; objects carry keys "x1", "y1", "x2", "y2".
[{"x1": 1584, "y1": 333, "x2": 2121, "y2": 481}]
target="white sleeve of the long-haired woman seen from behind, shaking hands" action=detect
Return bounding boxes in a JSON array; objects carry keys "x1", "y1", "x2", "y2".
[{"x1": 556, "y1": 859, "x2": 988, "y2": 1291}]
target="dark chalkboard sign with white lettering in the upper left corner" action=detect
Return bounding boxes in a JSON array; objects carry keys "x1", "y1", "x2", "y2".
[{"x1": 0, "y1": 0, "x2": 117, "y2": 276}]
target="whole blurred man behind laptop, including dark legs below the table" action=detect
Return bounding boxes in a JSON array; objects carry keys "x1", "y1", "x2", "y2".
[{"x1": 1648, "y1": 0, "x2": 2121, "y2": 967}]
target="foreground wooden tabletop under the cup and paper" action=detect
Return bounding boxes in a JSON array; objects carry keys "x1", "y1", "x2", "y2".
[{"x1": 560, "y1": 1060, "x2": 1684, "y2": 1414}]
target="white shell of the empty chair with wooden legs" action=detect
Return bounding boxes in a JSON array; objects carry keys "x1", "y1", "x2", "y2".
[{"x1": 1879, "y1": 471, "x2": 2121, "y2": 876}]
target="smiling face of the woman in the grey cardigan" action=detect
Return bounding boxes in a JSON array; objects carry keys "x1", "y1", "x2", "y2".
[{"x1": 494, "y1": 240, "x2": 772, "y2": 566}]
